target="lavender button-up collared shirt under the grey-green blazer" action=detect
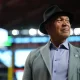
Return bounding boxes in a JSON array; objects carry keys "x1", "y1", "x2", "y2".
[{"x1": 50, "y1": 40, "x2": 69, "y2": 80}]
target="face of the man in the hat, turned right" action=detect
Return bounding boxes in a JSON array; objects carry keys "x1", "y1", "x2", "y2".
[{"x1": 46, "y1": 16, "x2": 71, "y2": 38}]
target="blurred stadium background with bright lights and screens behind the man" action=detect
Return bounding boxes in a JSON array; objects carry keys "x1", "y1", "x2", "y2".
[{"x1": 0, "y1": 0, "x2": 80, "y2": 80}]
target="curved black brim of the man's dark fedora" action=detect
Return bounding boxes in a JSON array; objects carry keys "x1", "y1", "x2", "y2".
[{"x1": 39, "y1": 11, "x2": 73, "y2": 34}]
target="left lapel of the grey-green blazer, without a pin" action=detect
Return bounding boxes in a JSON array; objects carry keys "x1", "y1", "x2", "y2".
[{"x1": 40, "y1": 42, "x2": 51, "y2": 75}]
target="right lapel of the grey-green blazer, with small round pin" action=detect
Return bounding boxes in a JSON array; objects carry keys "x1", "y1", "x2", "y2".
[{"x1": 68, "y1": 44, "x2": 79, "y2": 80}]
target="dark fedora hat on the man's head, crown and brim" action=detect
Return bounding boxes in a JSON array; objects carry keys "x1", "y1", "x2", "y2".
[{"x1": 39, "y1": 5, "x2": 73, "y2": 34}]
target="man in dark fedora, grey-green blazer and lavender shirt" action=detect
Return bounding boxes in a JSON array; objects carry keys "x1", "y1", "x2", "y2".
[{"x1": 23, "y1": 5, "x2": 80, "y2": 80}]
